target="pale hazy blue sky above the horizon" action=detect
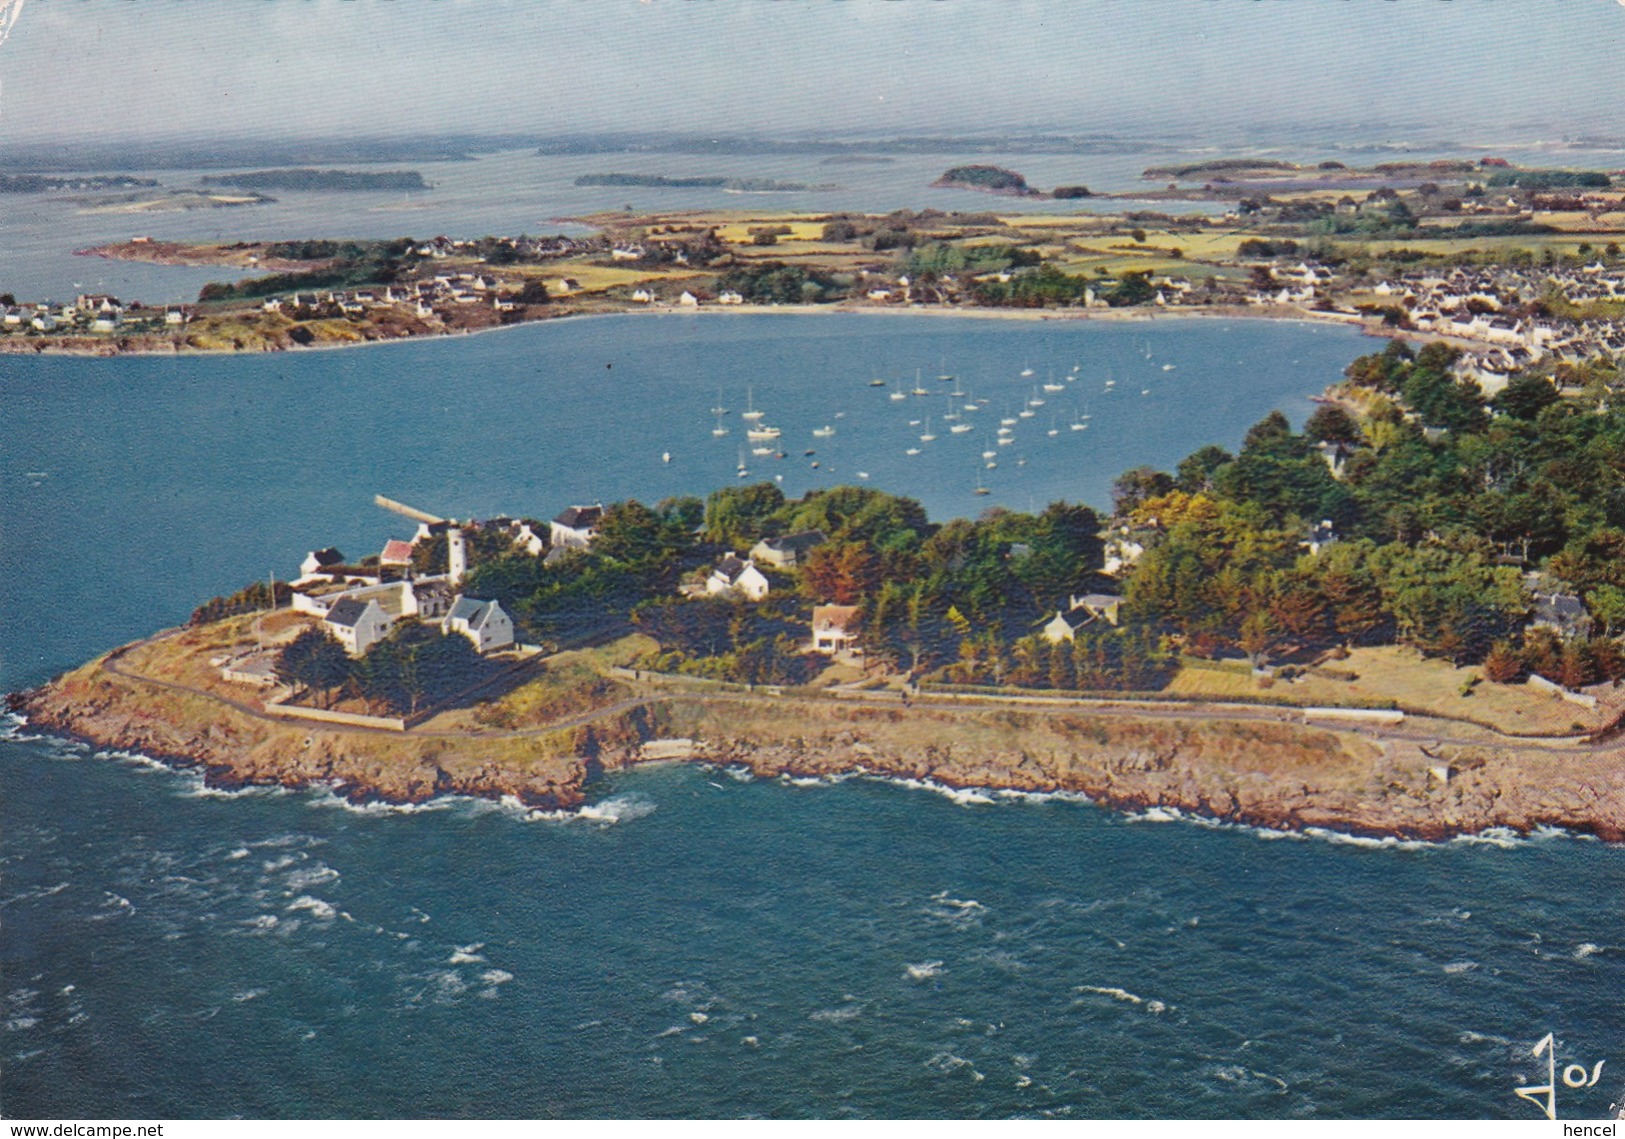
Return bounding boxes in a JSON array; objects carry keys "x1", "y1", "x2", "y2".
[{"x1": 0, "y1": 0, "x2": 1625, "y2": 141}]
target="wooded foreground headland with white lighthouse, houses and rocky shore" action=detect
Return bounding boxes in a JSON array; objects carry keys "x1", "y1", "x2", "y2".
[{"x1": 19, "y1": 350, "x2": 1625, "y2": 842}]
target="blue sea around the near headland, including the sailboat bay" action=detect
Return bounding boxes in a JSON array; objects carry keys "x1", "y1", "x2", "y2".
[{"x1": 0, "y1": 314, "x2": 1625, "y2": 1120}]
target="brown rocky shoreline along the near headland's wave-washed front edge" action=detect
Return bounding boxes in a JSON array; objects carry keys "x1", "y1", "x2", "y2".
[{"x1": 8, "y1": 663, "x2": 1625, "y2": 842}]
